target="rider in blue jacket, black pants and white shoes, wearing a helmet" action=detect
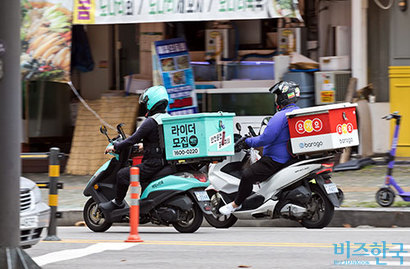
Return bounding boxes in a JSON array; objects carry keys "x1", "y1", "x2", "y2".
[{"x1": 219, "y1": 81, "x2": 300, "y2": 215}]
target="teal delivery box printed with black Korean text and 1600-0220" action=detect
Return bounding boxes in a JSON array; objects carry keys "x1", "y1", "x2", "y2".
[{"x1": 162, "y1": 112, "x2": 235, "y2": 161}]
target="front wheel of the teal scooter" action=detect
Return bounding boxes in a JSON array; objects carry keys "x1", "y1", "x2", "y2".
[{"x1": 83, "y1": 198, "x2": 112, "y2": 232}]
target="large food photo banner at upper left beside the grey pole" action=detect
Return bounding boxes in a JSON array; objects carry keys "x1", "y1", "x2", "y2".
[{"x1": 20, "y1": 0, "x2": 73, "y2": 82}]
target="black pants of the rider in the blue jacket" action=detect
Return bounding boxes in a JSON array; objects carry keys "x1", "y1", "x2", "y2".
[{"x1": 235, "y1": 156, "x2": 285, "y2": 205}]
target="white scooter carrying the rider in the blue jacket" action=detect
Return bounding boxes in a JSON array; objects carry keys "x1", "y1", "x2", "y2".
[{"x1": 205, "y1": 119, "x2": 343, "y2": 228}]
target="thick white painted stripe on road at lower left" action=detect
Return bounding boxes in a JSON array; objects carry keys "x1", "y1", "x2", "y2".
[{"x1": 33, "y1": 241, "x2": 138, "y2": 266}]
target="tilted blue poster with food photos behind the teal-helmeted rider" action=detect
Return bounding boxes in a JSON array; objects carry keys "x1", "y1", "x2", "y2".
[{"x1": 154, "y1": 38, "x2": 198, "y2": 115}]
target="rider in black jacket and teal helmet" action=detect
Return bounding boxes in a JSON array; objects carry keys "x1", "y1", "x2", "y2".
[{"x1": 99, "y1": 86, "x2": 169, "y2": 211}]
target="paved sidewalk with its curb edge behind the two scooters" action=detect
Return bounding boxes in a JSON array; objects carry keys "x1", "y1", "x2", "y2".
[{"x1": 23, "y1": 165, "x2": 410, "y2": 227}]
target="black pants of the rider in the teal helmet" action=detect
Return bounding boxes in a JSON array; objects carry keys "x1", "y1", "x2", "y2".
[{"x1": 115, "y1": 160, "x2": 164, "y2": 202}]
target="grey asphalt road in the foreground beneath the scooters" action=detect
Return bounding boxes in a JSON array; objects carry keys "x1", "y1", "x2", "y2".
[{"x1": 26, "y1": 226, "x2": 410, "y2": 269}]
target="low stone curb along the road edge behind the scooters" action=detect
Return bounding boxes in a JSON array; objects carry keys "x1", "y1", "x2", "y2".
[{"x1": 57, "y1": 208, "x2": 410, "y2": 228}]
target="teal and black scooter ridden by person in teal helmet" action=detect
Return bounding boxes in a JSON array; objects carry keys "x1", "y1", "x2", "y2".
[{"x1": 83, "y1": 124, "x2": 212, "y2": 233}]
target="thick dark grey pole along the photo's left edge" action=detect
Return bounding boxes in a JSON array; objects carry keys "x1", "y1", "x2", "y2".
[{"x1": 0, "y1": 0, "x2": 40, "y2": 264}]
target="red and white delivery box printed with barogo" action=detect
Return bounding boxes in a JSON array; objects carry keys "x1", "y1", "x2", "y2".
[{"x1": 286, "y1": 103, "x2": 359, "y2": 154}]
